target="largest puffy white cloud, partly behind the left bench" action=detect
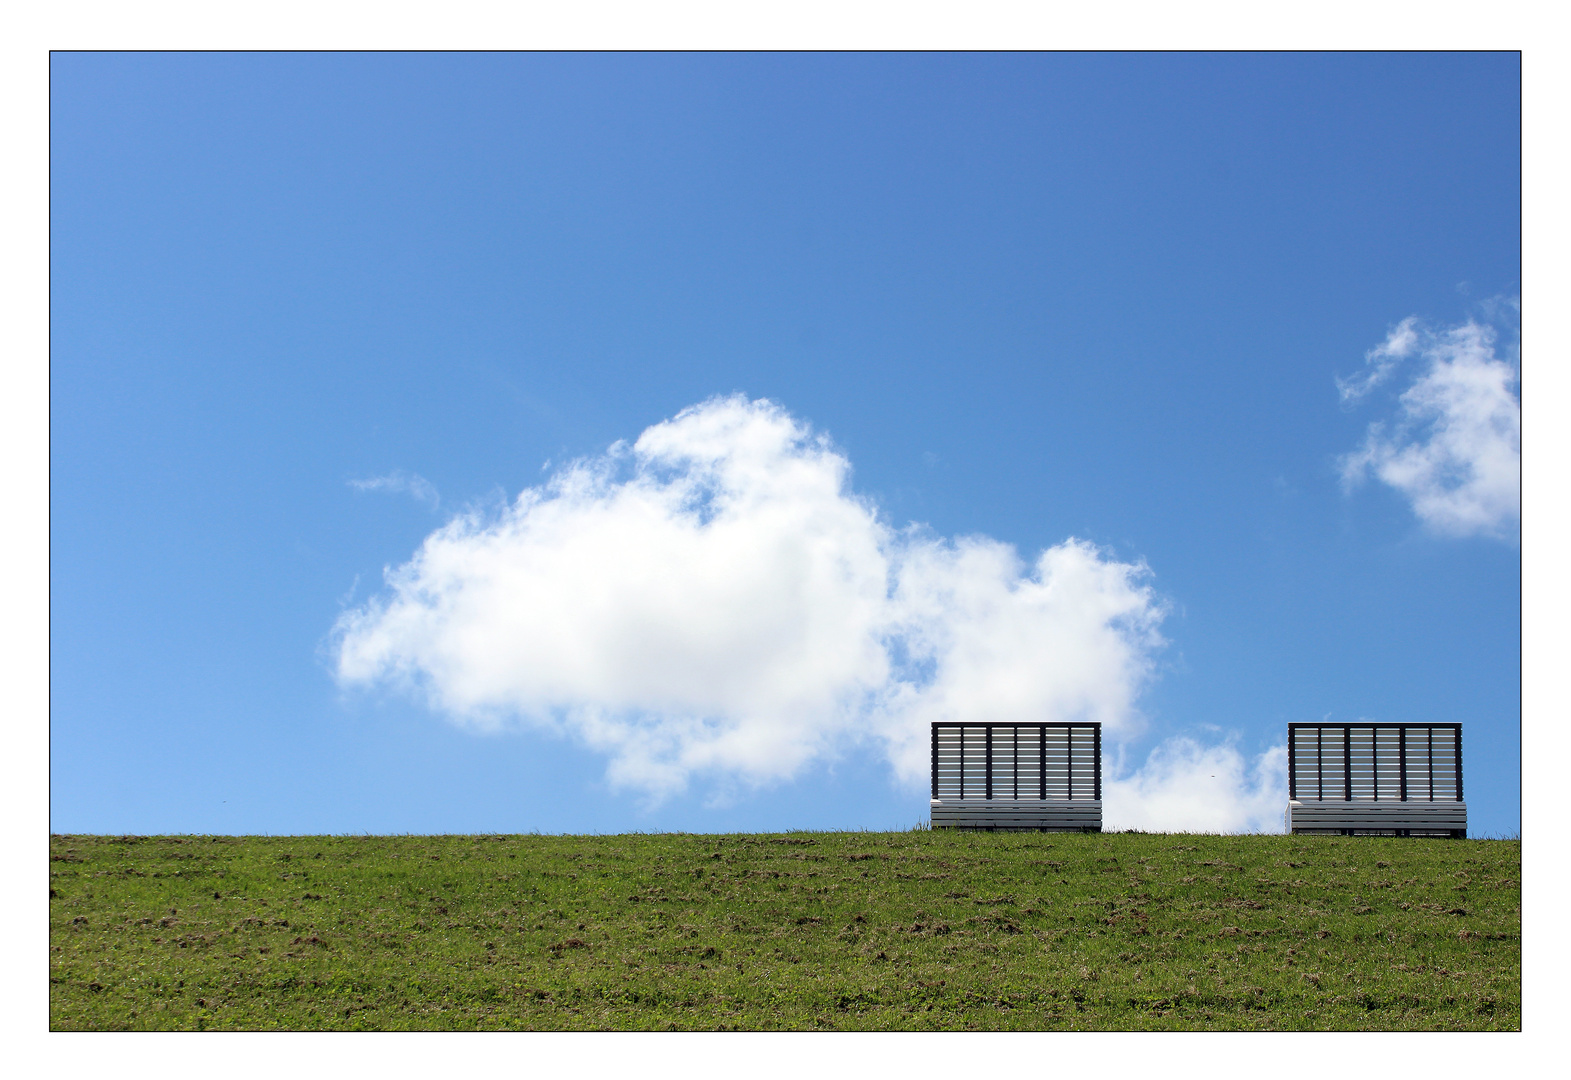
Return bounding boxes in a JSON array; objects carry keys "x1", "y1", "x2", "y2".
[{"x1": 335, "y1": 396, "x2": 1163, "y2": 799}]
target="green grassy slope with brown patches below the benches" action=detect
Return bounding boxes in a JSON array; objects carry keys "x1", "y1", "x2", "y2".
[{"x1": 49, "y1": 832, "x2": 1522, "y2": 1030}]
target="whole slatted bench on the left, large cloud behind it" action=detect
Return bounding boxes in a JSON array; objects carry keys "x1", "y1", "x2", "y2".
[{"x1": 932, "y1": 723, "x2": 1101, "y2": 833}]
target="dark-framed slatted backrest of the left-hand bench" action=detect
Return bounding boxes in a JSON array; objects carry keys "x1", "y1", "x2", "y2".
[{"x1": 933, "y1": 723, "x2": 1101, "y2": 800}]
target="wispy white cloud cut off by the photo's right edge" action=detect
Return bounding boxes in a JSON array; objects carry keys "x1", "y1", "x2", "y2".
[{"x1": 1338, "y1": 308, "x2": 1522, "y2": 536}]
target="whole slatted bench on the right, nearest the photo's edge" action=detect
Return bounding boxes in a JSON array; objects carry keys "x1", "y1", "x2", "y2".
[{"x1": 1284, "y1": 723, "x2": 1467, "y2": 838}]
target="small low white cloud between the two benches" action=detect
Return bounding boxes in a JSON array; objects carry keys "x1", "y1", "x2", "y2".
[{"x1": 1101, "y1": 737, "x2": 1287, "y2": 833}]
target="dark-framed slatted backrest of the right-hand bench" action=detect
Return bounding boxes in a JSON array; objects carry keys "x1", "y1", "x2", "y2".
[{"x1": 1287, "y1": 723, "x2": 1463, "y2": 802}]
